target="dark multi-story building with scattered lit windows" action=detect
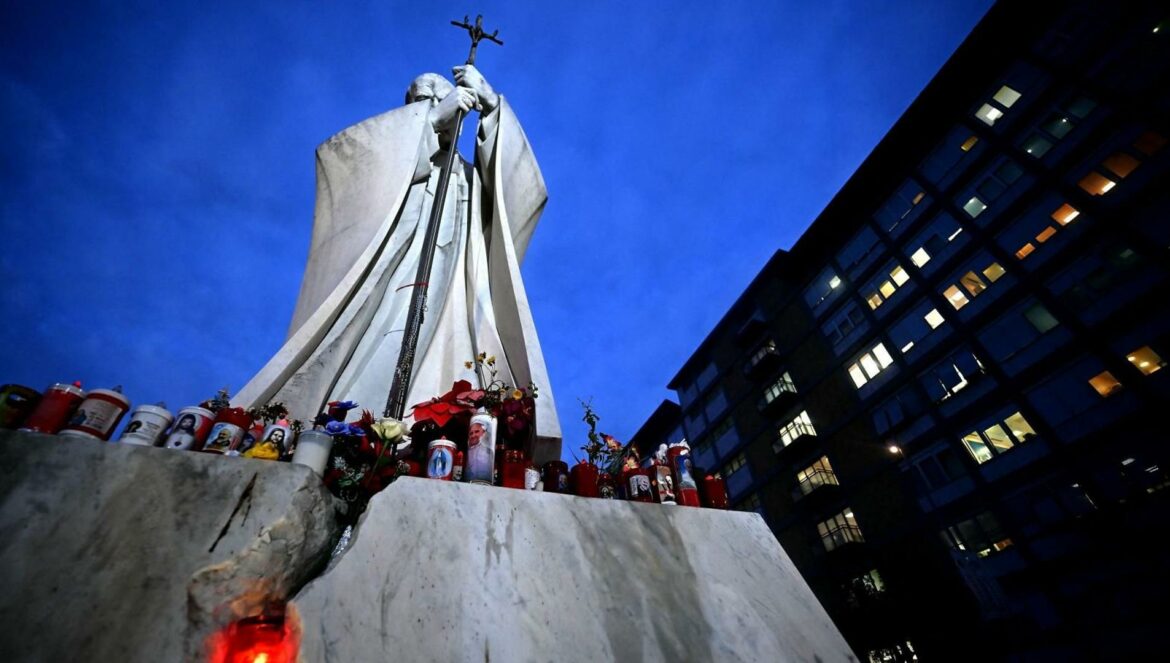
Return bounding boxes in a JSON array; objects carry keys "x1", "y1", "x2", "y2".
[{"x1": 655, "y1": 2, "x2": 1170, "y2": 661}]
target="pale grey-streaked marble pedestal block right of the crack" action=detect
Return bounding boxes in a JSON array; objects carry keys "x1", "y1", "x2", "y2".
[{"x1": 294, "y1": 478, "x2": 854, "y2": 663}]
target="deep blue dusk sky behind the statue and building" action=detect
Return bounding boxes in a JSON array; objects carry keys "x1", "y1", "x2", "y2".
[{"x1": 0, "y1": 0, "x2": 991, "y2": 458}]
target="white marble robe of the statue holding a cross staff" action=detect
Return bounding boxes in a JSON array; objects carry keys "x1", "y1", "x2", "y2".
[{"x1": 234, "y1": 97, "x2": 560, "y2": 462}]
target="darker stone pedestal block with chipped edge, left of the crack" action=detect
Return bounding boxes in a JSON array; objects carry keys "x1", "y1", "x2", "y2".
[{"x1": 0, "y1": 430, "x2": 335, "y2": 663}]
